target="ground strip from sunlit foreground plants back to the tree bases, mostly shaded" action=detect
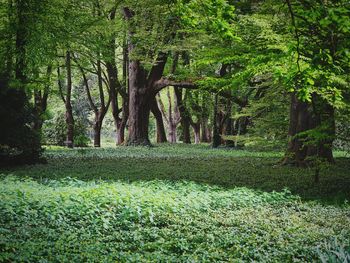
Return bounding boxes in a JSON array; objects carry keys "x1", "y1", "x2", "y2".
[{"x1": 0, "y1": 144, "x2": 350, "y2": 204}]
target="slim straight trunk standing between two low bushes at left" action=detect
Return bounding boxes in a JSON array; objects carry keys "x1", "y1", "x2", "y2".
[{"x1": 65, "y1": 51, "x2": 74, "y2": 148}]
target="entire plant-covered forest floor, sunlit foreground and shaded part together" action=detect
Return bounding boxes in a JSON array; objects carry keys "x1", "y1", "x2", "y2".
[{"x1": 0, "y1": 145, "x2": 350, "y2": 262}]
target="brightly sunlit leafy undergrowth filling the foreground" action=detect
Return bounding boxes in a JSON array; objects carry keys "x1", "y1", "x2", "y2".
[{"x1": 0, "y1": 176, "x2": 350, "y2": 262}]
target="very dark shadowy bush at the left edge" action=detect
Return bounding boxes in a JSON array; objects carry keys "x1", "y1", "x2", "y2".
[{"x1": 0, "y1": 77, "x2": 42, "y2": 165}]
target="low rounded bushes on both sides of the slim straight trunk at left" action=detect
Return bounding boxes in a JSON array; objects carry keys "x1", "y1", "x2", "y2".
[{"x1": 42, "y1": 112, "x2": 90, "y2": 147}]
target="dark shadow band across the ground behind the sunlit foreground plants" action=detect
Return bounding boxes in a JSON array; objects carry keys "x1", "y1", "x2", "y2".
[{"x1": 0, "y1": 151, "x2": 350, "y2": 204}]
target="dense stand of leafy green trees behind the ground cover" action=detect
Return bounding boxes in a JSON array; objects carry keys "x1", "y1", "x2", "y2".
[{"x1": 0, "y1": 0, "x2": 350, "y2": 165}]
